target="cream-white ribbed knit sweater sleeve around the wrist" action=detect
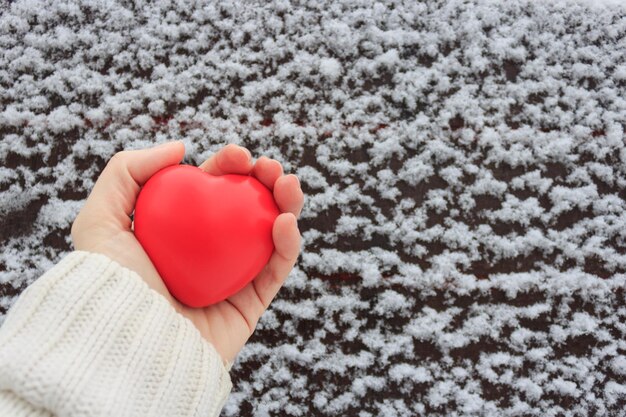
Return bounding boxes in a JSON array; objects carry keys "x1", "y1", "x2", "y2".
[{"x1": 0, "y1": 251, "x2": 232, "y2": 417}]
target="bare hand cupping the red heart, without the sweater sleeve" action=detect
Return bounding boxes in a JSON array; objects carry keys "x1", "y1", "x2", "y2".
[{"x1": 72, "y1": 142, "x2": 304, "y2": 362}]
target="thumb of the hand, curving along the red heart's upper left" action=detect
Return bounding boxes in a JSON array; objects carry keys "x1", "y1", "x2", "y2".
[{"x1": 80, "y1": 141, "x2": 185, "y2": 230}]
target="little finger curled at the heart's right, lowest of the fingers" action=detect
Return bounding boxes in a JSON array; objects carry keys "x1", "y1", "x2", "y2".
[{"x1": 253, "y1": 213, "x2": 301, "y2": 308}]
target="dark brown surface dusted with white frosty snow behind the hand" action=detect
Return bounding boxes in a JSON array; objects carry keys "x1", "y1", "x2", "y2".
[{"x1": 0, "y1": 0, "x2": 626, "y2": 417}]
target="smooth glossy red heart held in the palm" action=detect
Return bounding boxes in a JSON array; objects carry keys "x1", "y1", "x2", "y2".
[{"x1": 134, "y1": 165, "x2": 280, "y2": 307}]
